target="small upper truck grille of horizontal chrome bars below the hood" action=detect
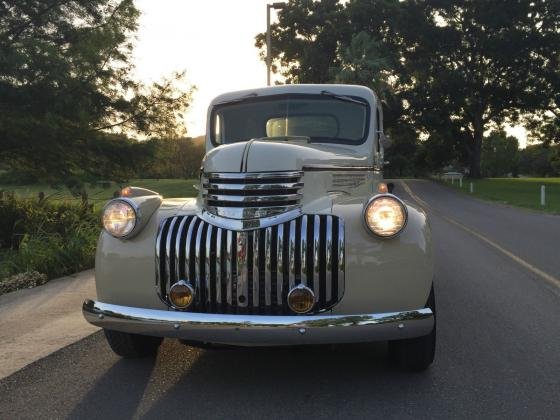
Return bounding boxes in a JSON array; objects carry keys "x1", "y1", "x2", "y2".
[{"x1": 202, "y1": 171, "x2": 303, "y2": 220}]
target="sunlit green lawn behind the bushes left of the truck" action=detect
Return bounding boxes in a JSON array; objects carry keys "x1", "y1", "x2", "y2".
[{"x1": 0, "y1": 179, "x2": 198, "y2": 207}]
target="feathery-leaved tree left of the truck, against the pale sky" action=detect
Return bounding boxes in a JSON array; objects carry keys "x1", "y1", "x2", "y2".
[{"x1": 0, "y1": 0, "x2": 191, "y2": 182}]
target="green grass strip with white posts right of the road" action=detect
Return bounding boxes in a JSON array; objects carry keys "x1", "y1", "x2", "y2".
[{"x1": 445, "y1": 178, "x2": 560, "y2": 214}]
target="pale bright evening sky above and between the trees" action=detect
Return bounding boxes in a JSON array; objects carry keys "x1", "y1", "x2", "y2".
[{"x1": 134, "y1": 0, "x2": 526, "y2": 147}]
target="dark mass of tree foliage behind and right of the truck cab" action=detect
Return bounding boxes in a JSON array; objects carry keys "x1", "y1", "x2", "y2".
[{"x1": 256, "y1": 0, "x2": 560, "y2": 177}]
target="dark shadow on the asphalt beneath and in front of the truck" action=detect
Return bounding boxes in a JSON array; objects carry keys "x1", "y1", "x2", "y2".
[{"x1": 70, "y1": 340, "x2": 438, "y2": 418}]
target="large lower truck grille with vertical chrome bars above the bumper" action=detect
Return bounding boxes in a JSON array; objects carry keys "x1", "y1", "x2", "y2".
[{"x1": 156, "y1": 215, "x2": 344, "y2": 315}]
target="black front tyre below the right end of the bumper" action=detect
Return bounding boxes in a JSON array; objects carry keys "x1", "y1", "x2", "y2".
[{"x1": 389, "y1": 285, "x2": 436, "y2": 371}]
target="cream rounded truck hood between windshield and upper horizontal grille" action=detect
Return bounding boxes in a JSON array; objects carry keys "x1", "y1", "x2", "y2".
[{"x1": 203, "y1": 140, "x2": 371, "y2": 173}]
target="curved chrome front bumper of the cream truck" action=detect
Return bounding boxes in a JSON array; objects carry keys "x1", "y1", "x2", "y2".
[{"x1": 83, "y1": 300, "x2": 434, "y2": 346}]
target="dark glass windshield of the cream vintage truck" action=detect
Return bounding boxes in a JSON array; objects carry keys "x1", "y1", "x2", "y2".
[{"x1": 211, "y1": 95, "x2": 369, "y2": 144}]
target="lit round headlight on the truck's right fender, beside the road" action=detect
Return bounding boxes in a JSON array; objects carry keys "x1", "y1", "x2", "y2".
[{"x1": 364, "y1": 194, "x2": 408, "y2": 238}]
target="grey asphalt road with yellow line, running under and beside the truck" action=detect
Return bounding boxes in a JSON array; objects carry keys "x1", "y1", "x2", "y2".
[{"x1": 0, "y1": 181, "x2": 560, "y2": 419}]
